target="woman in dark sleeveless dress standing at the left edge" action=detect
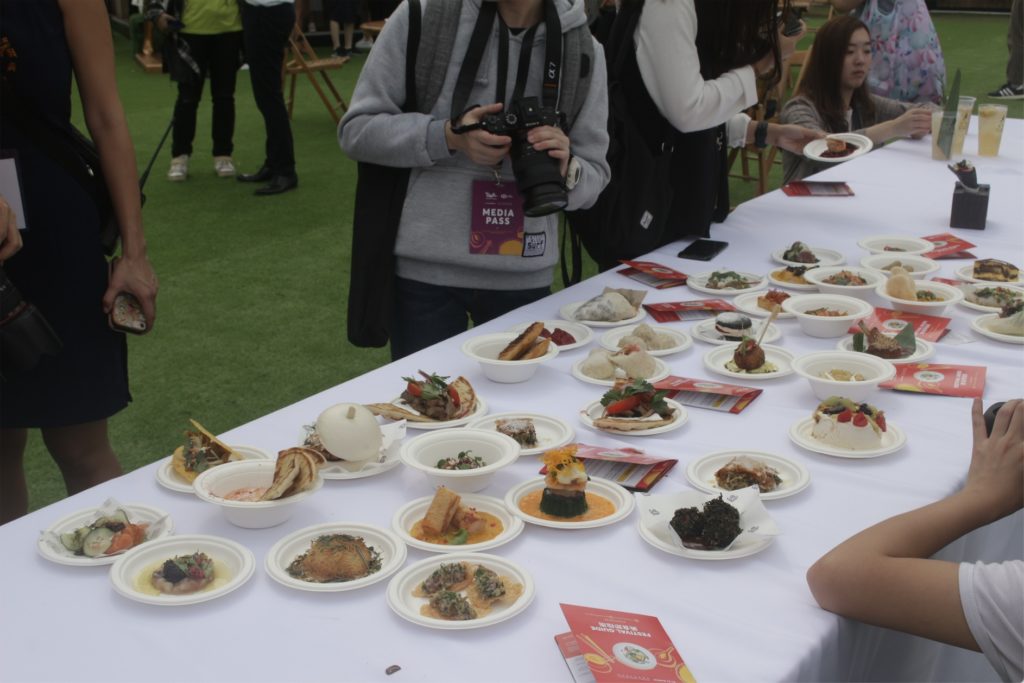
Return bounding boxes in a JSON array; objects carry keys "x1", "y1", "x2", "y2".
[{"x1": 0, "y1": 0, "x2": 157, "y2": 521}]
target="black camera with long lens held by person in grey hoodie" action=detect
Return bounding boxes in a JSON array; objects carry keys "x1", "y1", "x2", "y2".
[{"x1": 480, "y1": 97, "x2": 569, "y2": 216}]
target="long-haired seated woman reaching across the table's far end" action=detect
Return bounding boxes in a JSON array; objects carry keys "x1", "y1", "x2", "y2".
[{"x1": 781, "y1": 16, "x2": 932, "y2": 182}]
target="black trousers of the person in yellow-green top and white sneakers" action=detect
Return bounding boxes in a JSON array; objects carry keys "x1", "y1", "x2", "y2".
[{"x1": 171, "y1": 31, "x2": 242, "y2": 157}]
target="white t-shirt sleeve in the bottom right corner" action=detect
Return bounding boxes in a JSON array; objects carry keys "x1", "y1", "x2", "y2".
[{"x1": 959, "y1": 560, "x2": 1024, "y2": 681}]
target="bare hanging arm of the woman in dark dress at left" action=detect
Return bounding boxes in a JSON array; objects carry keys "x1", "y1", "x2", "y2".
[{"x1": 58, "y1": 0, "x2": 158, "y2": 328}]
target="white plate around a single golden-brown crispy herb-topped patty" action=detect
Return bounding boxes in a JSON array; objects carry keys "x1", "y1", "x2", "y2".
[{"x1": 263, "y1": 522, "x2": 408, "y2": 593}]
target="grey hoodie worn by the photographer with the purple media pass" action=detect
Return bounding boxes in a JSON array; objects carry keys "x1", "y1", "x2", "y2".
[{"x1": 338, "y1": 0, "x2": 609, "y2": 290}]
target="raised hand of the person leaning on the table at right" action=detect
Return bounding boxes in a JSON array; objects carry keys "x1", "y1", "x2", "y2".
[{"x1": 964, "y1": 398, "x2": 1024, "y2": 519}]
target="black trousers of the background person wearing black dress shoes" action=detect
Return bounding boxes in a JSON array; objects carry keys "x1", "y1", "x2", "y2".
[{"x1": 242, "y1": 2, "x2": 295, "y2": 175}]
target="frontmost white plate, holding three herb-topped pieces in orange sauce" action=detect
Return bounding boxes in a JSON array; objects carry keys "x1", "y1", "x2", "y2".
[{"x1": 387, "y1": 553, "x2": 537, "y2": 631}]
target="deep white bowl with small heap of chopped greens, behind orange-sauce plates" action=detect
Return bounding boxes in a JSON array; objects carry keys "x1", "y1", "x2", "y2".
[{"x1": 401, "y1": 429, "x2": 519, "y2": 494}]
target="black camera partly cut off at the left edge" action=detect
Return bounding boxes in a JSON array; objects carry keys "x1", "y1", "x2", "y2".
[{"x1": 0, "y1": 266, "x2": 60, "y2": 377}]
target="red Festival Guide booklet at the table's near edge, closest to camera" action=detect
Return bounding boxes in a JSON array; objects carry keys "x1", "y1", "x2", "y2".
[{"x1": 555, "y1": 604, "x2": 696, "y2": 683}]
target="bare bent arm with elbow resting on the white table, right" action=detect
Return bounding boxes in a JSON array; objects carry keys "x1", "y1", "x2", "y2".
[{"x1": 807, "y1": 399, "x2": 1024, "y2": 650}]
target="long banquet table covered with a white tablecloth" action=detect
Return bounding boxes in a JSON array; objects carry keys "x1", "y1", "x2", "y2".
[{"x1": 0, "y1": 120, "x2": 1024, "y2": 683}]
